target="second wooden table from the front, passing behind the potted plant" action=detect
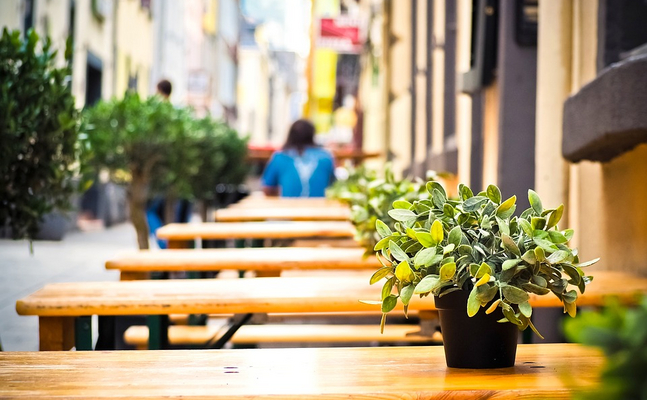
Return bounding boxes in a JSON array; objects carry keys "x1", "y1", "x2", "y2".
[{"x1": 16, "y1": 272, "x2": 647, "y2": 350}]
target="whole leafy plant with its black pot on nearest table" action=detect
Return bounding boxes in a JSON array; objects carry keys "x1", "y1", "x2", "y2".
[{"x1": 370, "y1": 182, "x2": 597, "y2": 368}]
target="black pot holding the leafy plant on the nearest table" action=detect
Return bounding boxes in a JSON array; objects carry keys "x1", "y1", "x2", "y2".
[{"x1": 434, "y1": 290, "x2": 519, "y2": 368}]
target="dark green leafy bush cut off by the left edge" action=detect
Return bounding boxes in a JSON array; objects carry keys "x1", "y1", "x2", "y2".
[{"x1": 0, "y1": 29, "x2": 79, "y2": 239}]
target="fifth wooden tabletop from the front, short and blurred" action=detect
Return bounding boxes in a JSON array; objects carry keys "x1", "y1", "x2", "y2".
[{"x1": 215, "y1": 206, "x2": 350, "y2": 222}]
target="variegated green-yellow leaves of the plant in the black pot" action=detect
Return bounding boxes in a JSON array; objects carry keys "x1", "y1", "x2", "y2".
[{"x1": 372, "y1": 182, "x2": 597, "y2": 336}]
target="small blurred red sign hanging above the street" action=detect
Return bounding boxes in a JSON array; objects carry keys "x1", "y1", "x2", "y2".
[{"x1": 317, "y1": 17, "x2": 362, "y2": 53}]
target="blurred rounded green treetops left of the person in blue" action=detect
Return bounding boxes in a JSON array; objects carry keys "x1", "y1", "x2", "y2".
[{"x1": 81, "y1": 93, "x2": 248, "y2": 199}]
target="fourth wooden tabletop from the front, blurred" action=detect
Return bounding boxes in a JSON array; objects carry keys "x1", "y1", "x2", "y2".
[{"x1": 156, "y1": 221, "x2": 355, "y2": 240}]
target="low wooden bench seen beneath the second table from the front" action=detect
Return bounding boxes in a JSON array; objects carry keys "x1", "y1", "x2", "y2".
[{"x1": 124, "y1": 324, "x2": 442, "y2": 350}]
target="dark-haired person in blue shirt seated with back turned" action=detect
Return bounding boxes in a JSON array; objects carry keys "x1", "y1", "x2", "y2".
[{"x1": 261, "y1": 119, "x2": 335, "y2": 197}]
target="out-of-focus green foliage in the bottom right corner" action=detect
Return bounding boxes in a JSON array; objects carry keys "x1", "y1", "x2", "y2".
[{"x1": 565, "y1": 297, "x2": 647, "y2": 400}]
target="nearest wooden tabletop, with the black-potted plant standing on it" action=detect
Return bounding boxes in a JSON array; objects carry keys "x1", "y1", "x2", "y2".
[{"x1": 0, "y1": 344, "x2": 604, "y2": 400}]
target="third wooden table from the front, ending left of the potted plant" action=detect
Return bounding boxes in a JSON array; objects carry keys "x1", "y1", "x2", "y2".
[{"x1": 106, "y1": 247, "x2": 381, "y2": 280}]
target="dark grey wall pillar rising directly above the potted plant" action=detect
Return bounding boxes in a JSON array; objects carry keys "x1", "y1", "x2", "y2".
[{"x1": 497, "y1": 1, "x2": 537, "y2": 211}]
